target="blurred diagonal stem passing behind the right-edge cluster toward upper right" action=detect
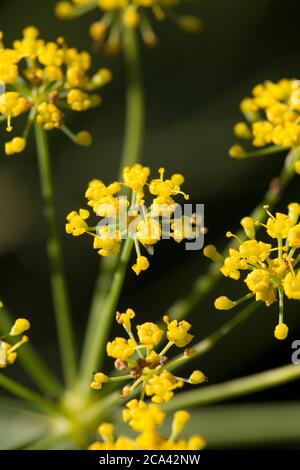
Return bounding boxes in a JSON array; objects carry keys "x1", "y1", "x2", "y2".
[{"x1": 168, "y1": 148, "x2": 300, "y2": 320}]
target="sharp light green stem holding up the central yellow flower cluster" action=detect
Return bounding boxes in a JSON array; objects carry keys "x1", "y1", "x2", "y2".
[{"x1": 80, "y1": 238, "x2": 133, "y2": 394}]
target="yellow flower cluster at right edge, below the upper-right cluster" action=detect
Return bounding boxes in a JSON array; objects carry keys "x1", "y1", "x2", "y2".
[{"x1": 204, "y1": 203, "x2": 300, "y2": 340}]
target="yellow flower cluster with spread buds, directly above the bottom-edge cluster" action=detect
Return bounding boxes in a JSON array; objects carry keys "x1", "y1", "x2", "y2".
[{"x1": 91, "y1": 309, "x2": 206, "y2": 404}]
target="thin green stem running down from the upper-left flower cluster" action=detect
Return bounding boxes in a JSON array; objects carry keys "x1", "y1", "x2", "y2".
[{"x1": 35, "y1": 124, "x2": 76, "y2": 386}]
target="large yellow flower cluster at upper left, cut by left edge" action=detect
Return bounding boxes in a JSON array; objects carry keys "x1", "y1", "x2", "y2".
[{"x1": 0, "y1": 26, "x2": 111, "y2": 155}]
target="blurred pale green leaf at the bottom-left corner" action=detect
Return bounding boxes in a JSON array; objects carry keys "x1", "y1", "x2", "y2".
[{"x1": 0, "y1": 398, "x2": 49, "y2": 450}]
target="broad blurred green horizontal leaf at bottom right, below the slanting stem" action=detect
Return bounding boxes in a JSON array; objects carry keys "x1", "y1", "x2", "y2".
[{"x1": 186, "y1": 402, "x2": 300, "y2": 449}]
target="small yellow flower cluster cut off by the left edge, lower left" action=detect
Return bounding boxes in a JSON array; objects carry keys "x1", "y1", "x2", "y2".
[{"x1": 0, "y1": 301, "x2": 30, "y2": 369}]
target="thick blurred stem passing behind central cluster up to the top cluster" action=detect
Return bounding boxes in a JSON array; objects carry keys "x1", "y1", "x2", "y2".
[{"x1": 81, "y1": 25, "x2": 145, "y2": 382}]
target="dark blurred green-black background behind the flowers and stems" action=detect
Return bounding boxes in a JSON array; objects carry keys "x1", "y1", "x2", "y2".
[{"x1": 0, "y1": 0, "x2": 300, "y2": 446}]
